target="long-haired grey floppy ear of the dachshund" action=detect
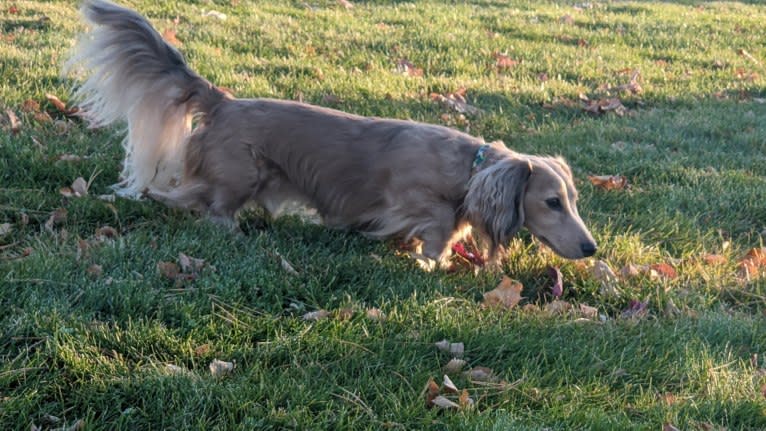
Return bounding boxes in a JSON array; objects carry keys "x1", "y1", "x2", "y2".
[{"x1": 463, "y1": 159, "x2": 532, "y2": 257}]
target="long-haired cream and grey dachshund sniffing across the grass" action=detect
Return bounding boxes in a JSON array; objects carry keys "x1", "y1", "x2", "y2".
[{"x1": 66, "y1": 0, "x2": 596, "y2": 266}]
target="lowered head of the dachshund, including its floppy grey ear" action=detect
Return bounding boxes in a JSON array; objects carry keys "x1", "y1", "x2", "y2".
[{"x1": 464, "y1": 154, "x2": 596, "y2": 259}]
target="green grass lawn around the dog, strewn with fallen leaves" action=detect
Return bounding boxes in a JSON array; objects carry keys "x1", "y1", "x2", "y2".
[{"x1": 0, "y1": 0, "x2": 766, "y2": 430}]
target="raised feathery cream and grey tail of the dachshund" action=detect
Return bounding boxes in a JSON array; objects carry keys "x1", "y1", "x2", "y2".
[{"x1": 64, "y1": 0, "x2": 229, "y2": 198}]
